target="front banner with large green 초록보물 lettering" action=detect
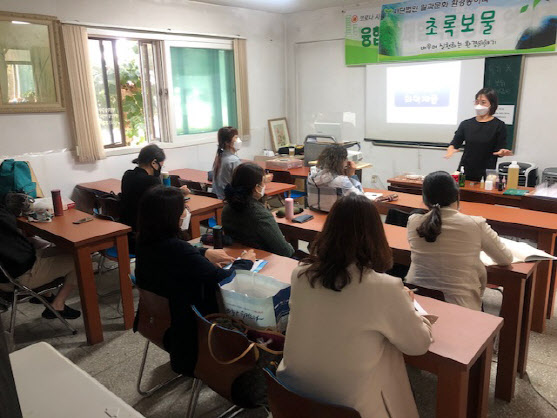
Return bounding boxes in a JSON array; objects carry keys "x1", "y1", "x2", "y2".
[{"x1": 379, "y1": 0, "x2": 557, "y2": 62}]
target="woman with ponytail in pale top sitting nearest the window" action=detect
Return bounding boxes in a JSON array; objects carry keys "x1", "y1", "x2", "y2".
[{"x1": 213, "y1": 126, "x2": 242, "y2": 199}]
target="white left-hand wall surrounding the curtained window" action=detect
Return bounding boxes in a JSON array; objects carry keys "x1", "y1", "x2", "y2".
[{"x1": 0, "y1": 0, "x2": 285, "y2": 196}]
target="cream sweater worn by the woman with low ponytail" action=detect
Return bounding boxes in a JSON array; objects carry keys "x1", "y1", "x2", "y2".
[{"x1": 406, "y1": 208, "x2": 513, "y2": 311}]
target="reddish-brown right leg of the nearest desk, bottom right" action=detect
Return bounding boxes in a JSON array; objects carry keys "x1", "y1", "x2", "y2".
[{"x1": 468, "y1": 339, "x2": 493, "y2": 418}]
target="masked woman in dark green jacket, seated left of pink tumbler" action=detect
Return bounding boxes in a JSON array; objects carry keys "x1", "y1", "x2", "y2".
[{"x1": 222, "y1": 163, "x2": 294, "y2": 257}]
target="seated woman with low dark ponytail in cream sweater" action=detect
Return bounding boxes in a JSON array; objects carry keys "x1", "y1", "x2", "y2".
[{"x1": 406, "y1": 171, "x2": 513, "y2": 310}]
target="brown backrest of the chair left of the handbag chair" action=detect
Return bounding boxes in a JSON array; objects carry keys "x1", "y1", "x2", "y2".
[{"x1": 137, "y1": 289, "x2": 170, "y2": 350}]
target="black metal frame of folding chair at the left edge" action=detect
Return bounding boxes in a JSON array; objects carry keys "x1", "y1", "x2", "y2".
[{"x1": 0, "y1": 264, "x2": 77, "y2": 340}]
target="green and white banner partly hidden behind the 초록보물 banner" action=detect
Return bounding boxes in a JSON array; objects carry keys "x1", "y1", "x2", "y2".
[{"x1": 344, "y1": 6, "x2": 381, "y2": 65}]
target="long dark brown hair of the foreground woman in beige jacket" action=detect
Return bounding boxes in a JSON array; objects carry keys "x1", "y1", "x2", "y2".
[{"x1": 302, "y1": 193, "x2": 393, "y2": 292}]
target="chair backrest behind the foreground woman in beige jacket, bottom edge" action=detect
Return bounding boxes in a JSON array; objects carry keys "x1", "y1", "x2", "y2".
[{"x1": 265, "y1": 369, "x2": 360, "y2": 418}]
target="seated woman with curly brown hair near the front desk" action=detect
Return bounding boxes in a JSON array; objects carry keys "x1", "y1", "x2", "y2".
[{"x1": 307, "y1": 145, "x2": 363, "y2": 212}]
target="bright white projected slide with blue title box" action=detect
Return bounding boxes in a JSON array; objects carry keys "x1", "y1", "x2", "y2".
[{"x1": 387, "y1": 61, "x2": 461, "y2": 125}]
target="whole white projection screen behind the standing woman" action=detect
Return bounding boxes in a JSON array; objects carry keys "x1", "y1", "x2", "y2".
[{"x1": 365, "y1": 58, "x2": 485, "y2": 144}]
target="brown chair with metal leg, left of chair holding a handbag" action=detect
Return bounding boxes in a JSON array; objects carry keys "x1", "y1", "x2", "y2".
[{"x1": 137, "y1": 289, "x2": 181, "y2": 396}]
